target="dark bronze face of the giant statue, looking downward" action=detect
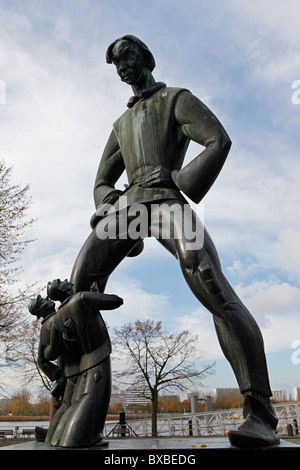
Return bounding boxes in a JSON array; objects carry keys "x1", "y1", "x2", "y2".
[{"x1": 112, "y1": 40, "x2": 144, "y2": 85}]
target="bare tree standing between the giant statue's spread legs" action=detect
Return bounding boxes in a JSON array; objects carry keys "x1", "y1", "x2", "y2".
[{"x1": 113, "y1": 320, "x2": 214, "y2": 437}]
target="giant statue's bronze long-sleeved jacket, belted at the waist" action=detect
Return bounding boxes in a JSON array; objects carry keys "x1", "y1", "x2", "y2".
[{"x1": 94, "y1": 83, "x2": 231, "y2": 208}]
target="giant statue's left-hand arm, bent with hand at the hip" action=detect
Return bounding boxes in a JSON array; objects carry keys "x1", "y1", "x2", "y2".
[{"x1": 94, "y1": 131, "x2": 124, "y2": 208}]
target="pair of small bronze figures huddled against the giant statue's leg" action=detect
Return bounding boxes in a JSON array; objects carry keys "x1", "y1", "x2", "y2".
[{"x1": 28, "y1": 279, "x2": 123, "y2": 448}]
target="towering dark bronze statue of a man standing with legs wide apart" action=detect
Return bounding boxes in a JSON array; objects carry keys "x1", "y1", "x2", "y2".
[{"x1": 70, "y1": 35, "x2": 279, "y2": 447}]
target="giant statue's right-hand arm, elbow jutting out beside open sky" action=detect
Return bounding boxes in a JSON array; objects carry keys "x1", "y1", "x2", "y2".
[{"x1": 172, "y1": 92, "x2": 231, "y2": 203}]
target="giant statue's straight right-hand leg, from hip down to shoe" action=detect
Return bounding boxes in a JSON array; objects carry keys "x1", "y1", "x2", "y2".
[{"x1": 155, "y1": 202, "x2": 278, "y2": 445}]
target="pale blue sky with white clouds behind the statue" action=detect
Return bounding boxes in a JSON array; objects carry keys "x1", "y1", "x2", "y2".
[{"x1": 0, "y1": 0, "x2": 300, "y2": 396}]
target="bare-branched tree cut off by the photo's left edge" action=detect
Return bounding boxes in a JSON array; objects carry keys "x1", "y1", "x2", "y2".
[{"x1": 0, "y1": 161, "x2": 34, "y2": 367}]
